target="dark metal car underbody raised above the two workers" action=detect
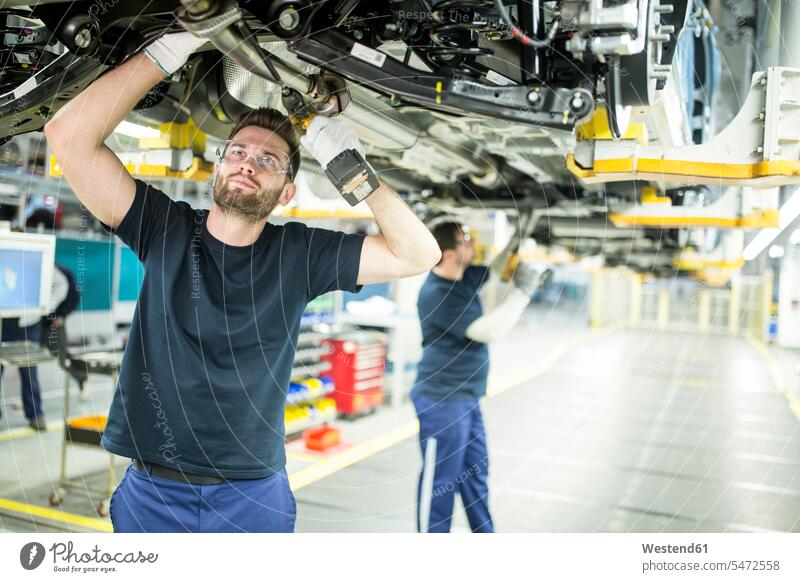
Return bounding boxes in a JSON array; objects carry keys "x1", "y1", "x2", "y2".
[{"x1": 0, "y1": 0, "x2": 772, "y2": 271}]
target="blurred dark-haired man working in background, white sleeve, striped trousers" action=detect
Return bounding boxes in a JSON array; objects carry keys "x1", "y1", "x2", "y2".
[{"x1": 411, "y1": 220, "x2": 539, "y2": 533}]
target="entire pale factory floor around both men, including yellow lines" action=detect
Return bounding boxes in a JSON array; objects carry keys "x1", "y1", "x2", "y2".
[{"x1": 0, "y1": 306, "x2": 800, "y2": 532}]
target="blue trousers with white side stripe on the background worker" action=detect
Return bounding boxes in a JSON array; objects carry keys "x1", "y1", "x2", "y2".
[{"x1": 411, "y1": 392, "x2": 494, "y2": 533}]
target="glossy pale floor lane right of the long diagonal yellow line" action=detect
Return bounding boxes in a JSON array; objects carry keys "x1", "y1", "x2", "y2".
[{"x1": 297, "y1": 324, "x2": 800, "y2": 532}]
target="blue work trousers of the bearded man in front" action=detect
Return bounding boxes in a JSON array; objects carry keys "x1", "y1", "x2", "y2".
[{"x1": 109, "y1": 463, "x2": 297, "y2": 533}]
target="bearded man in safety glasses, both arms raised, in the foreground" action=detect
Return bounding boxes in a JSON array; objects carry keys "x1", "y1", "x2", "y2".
[{"x1": 45, "y1": 33, "x2": 440, "y2": 532}]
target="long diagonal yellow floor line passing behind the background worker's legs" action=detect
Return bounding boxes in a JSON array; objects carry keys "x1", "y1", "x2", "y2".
[{"x1": 289, "y1": 326, "x2": 620, "y2": 491}]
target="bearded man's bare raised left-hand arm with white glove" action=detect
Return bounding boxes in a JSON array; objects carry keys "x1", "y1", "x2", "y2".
[{"x1": 44, "y1": 32, "x2": 204, "y2": 228}]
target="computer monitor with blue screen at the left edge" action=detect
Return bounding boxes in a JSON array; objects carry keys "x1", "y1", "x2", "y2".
[{"x1": 0, "y1": 230, "x2": 56, "y2": 318}]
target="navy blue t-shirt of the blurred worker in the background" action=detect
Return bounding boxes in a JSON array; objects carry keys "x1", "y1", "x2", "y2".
[{"x1": 414, "y1": 267, "x2": 489, "y2": 400}]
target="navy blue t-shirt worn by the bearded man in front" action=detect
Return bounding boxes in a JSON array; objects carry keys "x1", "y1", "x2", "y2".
[{"x1": 101, "y1": 180, "x2": 364, "y2": 479}]
